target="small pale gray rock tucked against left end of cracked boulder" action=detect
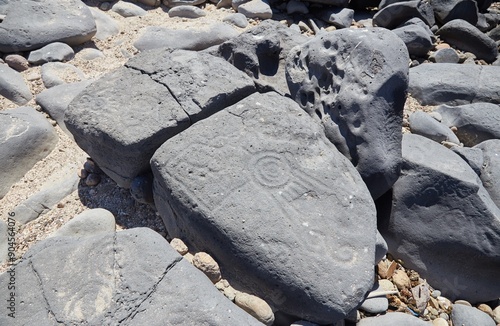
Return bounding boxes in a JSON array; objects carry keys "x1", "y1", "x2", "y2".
[{"x1": 35, "y1": 80, "x2": 92, "y2": 137}]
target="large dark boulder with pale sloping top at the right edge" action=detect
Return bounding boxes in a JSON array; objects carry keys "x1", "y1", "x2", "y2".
[{"x1": 379, "y1": 134, "x2": 500, "y2": 303}]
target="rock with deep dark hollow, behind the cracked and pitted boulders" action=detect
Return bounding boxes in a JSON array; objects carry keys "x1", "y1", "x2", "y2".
[{"x1": 211, "y1": 20, "x2": 308, "y2": 95}]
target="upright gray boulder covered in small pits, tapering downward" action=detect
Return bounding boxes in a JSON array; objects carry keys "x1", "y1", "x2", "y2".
[{"x1": 286, "y1": 28, "x2": 408, "y2": 199}]
